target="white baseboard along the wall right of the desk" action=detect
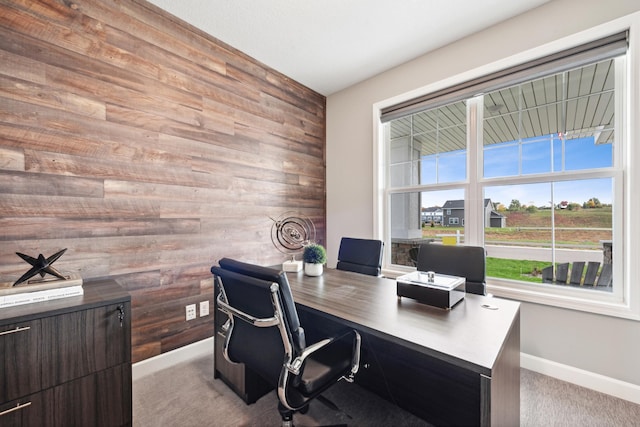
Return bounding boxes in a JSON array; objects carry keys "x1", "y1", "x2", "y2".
[{"x1": 520, "y1": 353, "x2": 640, "y2": 404}]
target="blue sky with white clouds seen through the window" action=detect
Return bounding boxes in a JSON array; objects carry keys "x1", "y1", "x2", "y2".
[{"x1": 421, "y1": 136, "x2": 613, "y2": 207}]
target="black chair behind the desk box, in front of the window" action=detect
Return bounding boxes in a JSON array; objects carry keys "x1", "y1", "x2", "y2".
[{"x1": 416, "y1": 243, "x2": 487, "y2": 295}]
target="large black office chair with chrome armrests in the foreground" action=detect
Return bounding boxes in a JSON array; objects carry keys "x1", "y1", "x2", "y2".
[{"x1": 211, "y1": 258, "x2": 360, "y2": 426}]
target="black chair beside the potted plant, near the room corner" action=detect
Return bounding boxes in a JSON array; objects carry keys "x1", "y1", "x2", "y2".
[{"x1": 336, "y1": 237, "x2": 384, "y2": 276}]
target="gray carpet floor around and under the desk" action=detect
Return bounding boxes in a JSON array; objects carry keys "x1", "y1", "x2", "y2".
[{"x1": 133, "y1": 356, "x2": 640, "y2": 427}]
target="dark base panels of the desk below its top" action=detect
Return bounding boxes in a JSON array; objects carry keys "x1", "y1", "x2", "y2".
[{"x1": 298, "y1": 307, "x2": 520, "y2": 426}]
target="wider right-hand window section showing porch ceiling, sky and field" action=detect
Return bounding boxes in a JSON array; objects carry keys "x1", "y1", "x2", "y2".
[{"x1": 474, "y1": 58, "x2": 624, "y2": 292}]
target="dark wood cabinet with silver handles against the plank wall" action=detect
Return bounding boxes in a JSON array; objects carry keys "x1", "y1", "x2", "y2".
[{"x1": 0, "y1": 280, "x2": 132, "y2": 426}]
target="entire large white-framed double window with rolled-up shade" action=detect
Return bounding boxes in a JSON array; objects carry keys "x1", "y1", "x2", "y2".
[{"x1": 381, "y1": 33, "x2": 629, "y2": 318}]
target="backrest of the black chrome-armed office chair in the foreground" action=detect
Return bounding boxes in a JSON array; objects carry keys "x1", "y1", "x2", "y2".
[{"x1": 211, "y1": 258, "x2": 306, "y2": 386}]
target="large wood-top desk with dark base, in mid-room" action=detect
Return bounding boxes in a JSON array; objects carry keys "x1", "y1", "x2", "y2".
[{"x1": 212, "y1": 269, "x2": 520, "y2": 426}]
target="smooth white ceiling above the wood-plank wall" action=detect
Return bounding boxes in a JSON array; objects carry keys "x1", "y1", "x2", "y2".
[{"x1": 149, "y1": 0, "x2": 550, "y2": 96}]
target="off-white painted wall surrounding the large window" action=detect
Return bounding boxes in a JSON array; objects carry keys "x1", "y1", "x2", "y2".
[{"x1": 326, "y1": 0, "x2": 640, "y2": 386}]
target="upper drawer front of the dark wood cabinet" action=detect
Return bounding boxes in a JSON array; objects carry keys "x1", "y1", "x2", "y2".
[{"x1": 0, "y1": 302, "x2": 131, "y2": 403}]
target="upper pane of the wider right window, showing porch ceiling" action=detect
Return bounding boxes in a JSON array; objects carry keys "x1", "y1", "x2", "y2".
[{"x1": 483, "y1": 60, "x2": 615, "y2": 178}]
